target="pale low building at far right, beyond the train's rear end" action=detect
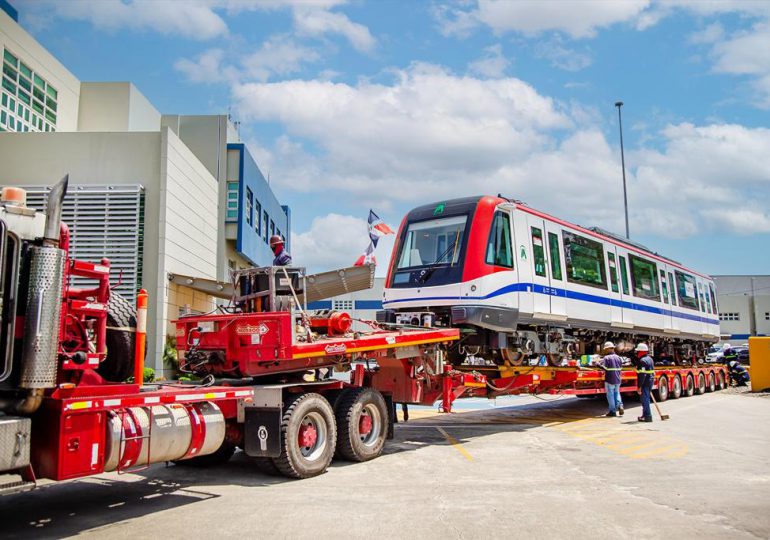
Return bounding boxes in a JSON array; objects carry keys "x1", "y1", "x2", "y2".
[{"x1": 713, "y1": 276, "x2": 770, "y2": 345}]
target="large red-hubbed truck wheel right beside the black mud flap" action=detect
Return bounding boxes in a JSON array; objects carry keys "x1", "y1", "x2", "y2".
[{"x1": 273, "y1": 393, "x2": 337, "y2": 478}]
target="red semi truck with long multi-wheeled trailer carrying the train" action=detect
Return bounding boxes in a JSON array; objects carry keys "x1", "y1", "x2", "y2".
[{"x1": 0, "y1": 177, "x2": 726, "y2": 494}]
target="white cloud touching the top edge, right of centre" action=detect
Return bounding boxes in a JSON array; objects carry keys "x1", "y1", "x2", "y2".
[{"x1": 434, "y1": 0, "x2": 650, "y2": 38}]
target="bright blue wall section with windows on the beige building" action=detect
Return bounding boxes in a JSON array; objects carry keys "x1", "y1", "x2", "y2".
[{"x1": 227, "y1": 143, "x2": 291, "y2": 266}]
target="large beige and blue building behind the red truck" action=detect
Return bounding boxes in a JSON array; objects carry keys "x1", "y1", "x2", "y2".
[{"x1": 0, "y1": 4, "x2": 290, "y2": 371}]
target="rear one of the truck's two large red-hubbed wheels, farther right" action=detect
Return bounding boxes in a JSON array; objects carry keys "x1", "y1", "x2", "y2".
[{"x1": 335, "y1": 388, "x2": 388, "y2": 461}]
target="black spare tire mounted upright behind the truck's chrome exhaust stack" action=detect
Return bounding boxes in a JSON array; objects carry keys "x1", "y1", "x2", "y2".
[{"x1": 101, "y1": 292, "x2": 137, "y2": 384}]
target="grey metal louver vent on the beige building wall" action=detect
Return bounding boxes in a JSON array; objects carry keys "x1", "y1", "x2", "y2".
[{"x1": 24, "y1": 184, "x2": 144, "y2": 303}]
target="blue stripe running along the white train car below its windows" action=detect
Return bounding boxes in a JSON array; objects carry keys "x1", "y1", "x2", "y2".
[{"x1": 382, "y1": 283, "x2": 719, "y2": 325}]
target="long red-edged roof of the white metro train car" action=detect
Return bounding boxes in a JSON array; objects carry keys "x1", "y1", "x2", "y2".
[{"x1": 408, "y1": 194, "x2": 711, "y2": 280}]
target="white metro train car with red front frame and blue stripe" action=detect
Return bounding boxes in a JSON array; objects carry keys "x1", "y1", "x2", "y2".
[{"x1": 378, "y1": 196, "x2": 719, "y2": 365}]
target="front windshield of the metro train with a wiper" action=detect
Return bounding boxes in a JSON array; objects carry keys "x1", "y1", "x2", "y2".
[{"x1": 396, "y1": 216, "x2": 468, "y2": 271}]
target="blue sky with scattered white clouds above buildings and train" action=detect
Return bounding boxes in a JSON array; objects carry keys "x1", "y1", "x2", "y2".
[{"x1": 11, "y1": 0, "x2": 770, "y2": 274}]
